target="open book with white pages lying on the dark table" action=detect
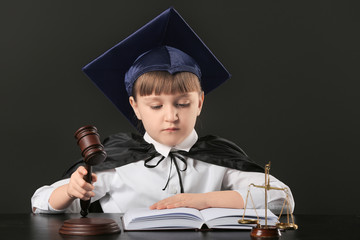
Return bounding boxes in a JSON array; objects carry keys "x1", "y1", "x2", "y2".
[{"x1": 123, "y1": 208, "x2": 278, "y2": 231}]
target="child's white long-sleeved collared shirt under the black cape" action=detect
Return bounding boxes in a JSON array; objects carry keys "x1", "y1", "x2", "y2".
[{"x1": 31, "y1": 130, "x2": 294, "y2": 213}]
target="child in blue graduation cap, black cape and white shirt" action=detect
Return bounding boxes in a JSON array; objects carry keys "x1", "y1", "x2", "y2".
[{"x1": 32, "y1": 8, "x2": 294, "y2": 213}]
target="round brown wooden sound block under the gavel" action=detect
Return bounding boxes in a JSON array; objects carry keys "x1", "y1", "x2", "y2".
[{"x1": 59, "y1": 218, "x2": 121, "y2": 236}]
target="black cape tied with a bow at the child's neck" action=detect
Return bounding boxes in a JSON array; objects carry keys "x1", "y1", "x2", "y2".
[{"x1": 63, "y1": 133, "x2": 264, "y2": 212}]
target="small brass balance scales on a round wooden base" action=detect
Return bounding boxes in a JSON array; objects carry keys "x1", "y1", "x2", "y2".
[{"x1": 238, "y1": 162, "x2": 298, "y2": 239}]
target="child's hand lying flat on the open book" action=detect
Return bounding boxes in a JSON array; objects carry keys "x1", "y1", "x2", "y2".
[{"x1": 150, "y1": 193, "x2": 209, "y2": 210}]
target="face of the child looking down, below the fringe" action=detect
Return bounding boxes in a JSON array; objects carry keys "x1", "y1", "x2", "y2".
[{"x1": 129, "y1": 92, "x2": 204, "y2": 146}]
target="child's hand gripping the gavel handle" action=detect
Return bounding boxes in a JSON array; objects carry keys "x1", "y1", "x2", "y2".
[{"x1": 66, "y1": 166, "x2": 97, "y2": 201}]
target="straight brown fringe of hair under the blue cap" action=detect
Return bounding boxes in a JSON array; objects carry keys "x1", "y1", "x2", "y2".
[{"x1": 132, "y1": 71, "x2": 202, "y2": 99}]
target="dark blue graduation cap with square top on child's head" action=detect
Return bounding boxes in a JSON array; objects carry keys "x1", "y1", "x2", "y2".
[{"x1": 82, "y1": 8, "x2": 230, "y2": 130}]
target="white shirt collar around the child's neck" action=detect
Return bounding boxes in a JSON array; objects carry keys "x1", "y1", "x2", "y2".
[{"x1": 144, "y1": 129, "x2": 198, "y2": 157}]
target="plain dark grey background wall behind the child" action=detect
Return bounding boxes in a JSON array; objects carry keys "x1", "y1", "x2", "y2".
[{"x1": 0, "y1": 0, "x2": 360, "y2": 214}]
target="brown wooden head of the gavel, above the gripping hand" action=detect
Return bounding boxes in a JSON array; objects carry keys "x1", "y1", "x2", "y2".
[{"x1": 75, "y1": 125, "x2": 106, "y2": 166}]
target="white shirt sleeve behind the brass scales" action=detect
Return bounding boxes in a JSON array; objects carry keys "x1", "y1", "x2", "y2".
[{"x1": 223, "y1": 169, "x2": 295, "y2": 214}]
